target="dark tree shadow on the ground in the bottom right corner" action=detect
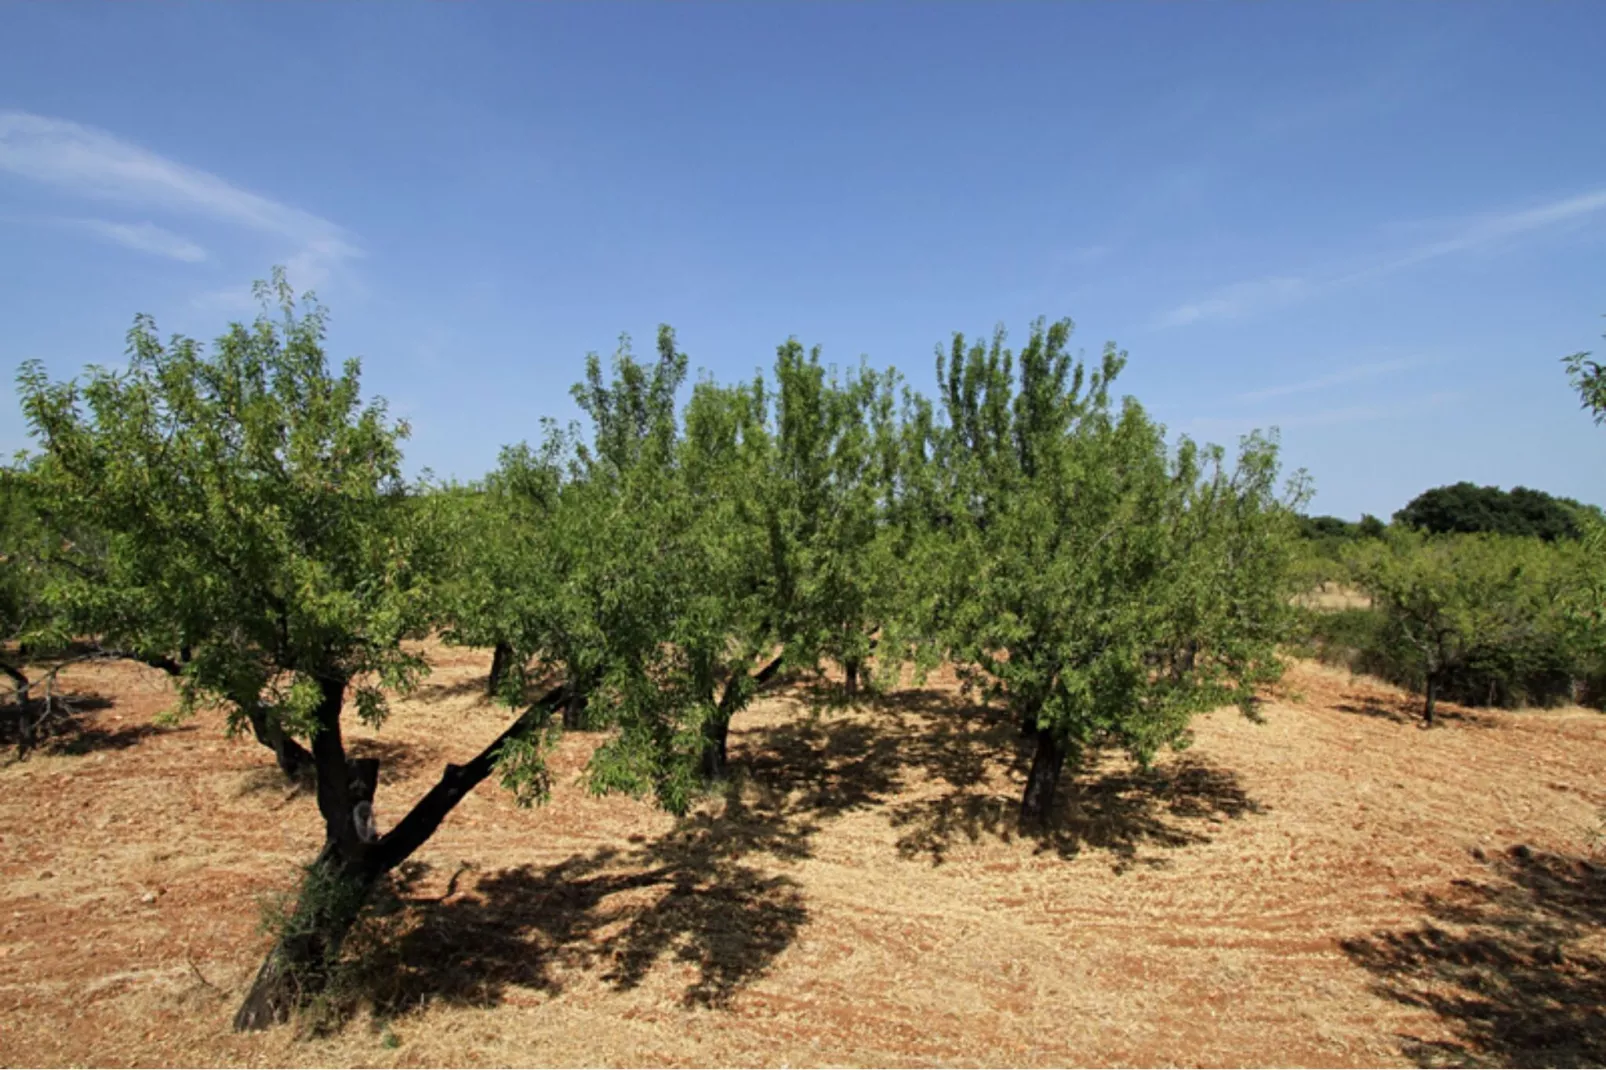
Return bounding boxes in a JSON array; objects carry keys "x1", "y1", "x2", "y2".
[{"x1": 1343, "y1": 847, "x2": 1606, "y2": 1067}]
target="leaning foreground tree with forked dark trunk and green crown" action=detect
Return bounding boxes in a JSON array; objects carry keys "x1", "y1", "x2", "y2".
[{"x1": 19, "y1": 273, "x2": 578, "y2": 1028}]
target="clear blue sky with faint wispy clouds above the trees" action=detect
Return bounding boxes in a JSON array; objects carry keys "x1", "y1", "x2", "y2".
[{"x1": 0, "y1": 2, "x2": 1606, "y2": 517}]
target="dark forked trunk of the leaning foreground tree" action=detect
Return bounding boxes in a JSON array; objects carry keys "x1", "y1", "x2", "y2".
[{"x1": 234, "y1": 676, "x2": 564, "y2": 1031}]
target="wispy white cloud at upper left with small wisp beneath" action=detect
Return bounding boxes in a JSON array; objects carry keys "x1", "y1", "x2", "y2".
[{"x1": 0, "y1": 111, "x2": 361, "y2": 286}]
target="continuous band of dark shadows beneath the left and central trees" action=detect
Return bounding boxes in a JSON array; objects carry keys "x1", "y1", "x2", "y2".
[{"x1": 329, "y1": 677, "x2": 1257, "y2": 1020}]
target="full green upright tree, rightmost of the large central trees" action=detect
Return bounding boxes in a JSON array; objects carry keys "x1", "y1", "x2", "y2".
[{"x1": 923, "y1": 321, "x2": 1301, "y2": 823}]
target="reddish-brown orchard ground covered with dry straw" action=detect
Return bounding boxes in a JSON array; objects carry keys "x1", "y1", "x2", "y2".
[{"x1": 0, "y1": 646, "x2": 1606, "y2": 1065}]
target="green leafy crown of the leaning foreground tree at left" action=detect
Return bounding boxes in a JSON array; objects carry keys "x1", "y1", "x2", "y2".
[{"x1": 18, "y1": 265, "x2": 437, "y2": 731}]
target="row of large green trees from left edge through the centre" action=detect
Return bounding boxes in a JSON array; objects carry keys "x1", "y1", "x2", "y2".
[{"x1": 0, "y1": 275, "x2": 1381, "y2": 1028}]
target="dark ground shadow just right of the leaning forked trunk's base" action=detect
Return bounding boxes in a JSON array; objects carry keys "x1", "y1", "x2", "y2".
[{"x1": 345, "y1": 787, "x2": 808, "y2": 1019}]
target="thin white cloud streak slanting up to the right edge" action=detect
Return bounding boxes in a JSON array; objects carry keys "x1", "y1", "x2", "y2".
[{"x1": 1155, "y1": 188, "x2": 1606, "y2": 328}]
